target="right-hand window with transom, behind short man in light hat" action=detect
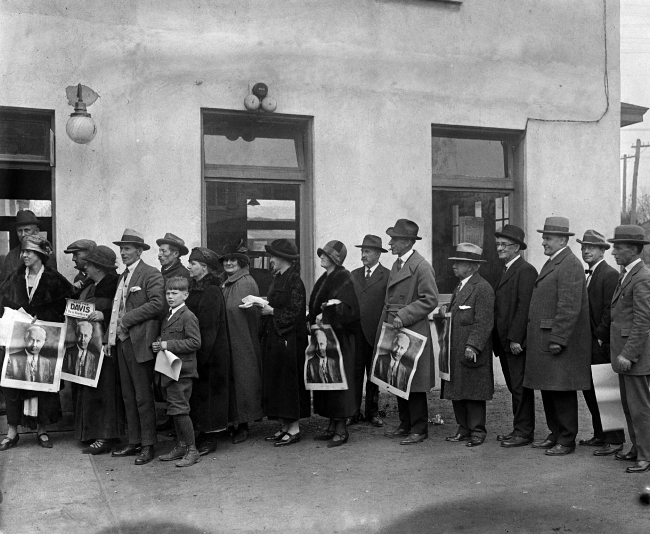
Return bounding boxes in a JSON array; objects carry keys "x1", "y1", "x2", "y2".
[{"x1": 431, "y1": 125, "x2": 522, "y2": 300}]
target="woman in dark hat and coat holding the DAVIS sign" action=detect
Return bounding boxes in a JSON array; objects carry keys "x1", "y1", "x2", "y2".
[{"x1": 73, "y1": 245, "x2": 124, "y2": 454}]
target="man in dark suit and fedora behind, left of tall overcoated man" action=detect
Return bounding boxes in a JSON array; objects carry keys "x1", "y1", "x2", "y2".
[{"x1": 348, "y1": 234, "x2": 390, "y2": 427}]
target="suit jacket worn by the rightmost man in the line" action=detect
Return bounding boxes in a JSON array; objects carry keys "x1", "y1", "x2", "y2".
[{"x1": 610, "y1": 260, "x2": 650, "y2": 376}]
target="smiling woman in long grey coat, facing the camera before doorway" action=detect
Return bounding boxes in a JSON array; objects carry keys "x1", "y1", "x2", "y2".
[{"x1": 219, "y1": 243, "x2": 264, "y2": 443}]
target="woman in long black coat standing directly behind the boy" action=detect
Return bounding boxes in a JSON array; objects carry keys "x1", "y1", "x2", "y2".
[{"x1": 185, "y1": 247, "x2": 230, "y2": 456}]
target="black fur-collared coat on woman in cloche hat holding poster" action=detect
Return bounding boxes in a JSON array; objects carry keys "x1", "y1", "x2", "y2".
[{"x1": 309, "y1": 267, "x2": 363, "y2": 418}]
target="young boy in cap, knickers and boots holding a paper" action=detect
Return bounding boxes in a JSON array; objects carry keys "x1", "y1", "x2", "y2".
[{"x1": 152, "y1": 276, "x2": 201, "y2": 467}]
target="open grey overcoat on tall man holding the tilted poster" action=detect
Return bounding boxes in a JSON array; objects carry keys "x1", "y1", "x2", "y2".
[{"x1": 376, "y1": 250, "x2": 438, "y2": 392}]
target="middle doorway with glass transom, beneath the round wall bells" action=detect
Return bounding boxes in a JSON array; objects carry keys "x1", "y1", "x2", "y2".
[{"x1": 203, "y1": 110, "x2": 313, "y2": 295}]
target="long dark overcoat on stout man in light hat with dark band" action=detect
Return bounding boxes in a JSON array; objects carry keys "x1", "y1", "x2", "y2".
[{"x1": 524, "y1": 247, "x2": 591, "y2": 391}]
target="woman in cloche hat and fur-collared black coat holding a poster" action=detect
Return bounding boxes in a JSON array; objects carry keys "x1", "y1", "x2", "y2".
[{"x1": 309, "y1": 241, "x2": 360, "y2": 447}]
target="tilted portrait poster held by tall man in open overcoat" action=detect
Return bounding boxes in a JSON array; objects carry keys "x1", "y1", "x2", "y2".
[{"x1": 370, "y1": 323, "x2": 427, "y2": 399}]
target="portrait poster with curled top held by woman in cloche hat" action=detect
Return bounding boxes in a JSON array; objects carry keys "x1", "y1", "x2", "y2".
[{"x1": 304, "y1": 324, "x2": 348, "y2": 391}]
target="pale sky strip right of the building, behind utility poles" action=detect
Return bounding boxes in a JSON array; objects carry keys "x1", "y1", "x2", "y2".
[{"x1": 620, "y1": 0, "x2": 650, "y2": 208}]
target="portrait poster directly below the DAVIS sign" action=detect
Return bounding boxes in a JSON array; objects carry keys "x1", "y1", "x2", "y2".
[{"x1": 61, "y1": 316, "x2": 104, "y2": 388}]
